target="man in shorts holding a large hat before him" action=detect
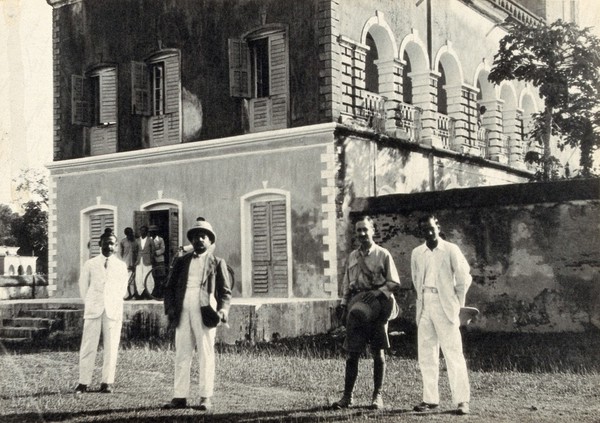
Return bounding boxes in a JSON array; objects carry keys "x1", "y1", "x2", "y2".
[{"x1": 332, "y1": 216, "x2": 400, "y2": 409}]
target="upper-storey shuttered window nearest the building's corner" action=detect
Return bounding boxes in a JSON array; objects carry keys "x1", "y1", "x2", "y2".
[{"x1": 229, "y1": 25, "x2": 289, "y2": 132}]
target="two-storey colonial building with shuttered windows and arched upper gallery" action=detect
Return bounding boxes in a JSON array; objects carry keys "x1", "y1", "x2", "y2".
[{"x1": 47, "y1": 0, "x2": 564, "y2": 332}]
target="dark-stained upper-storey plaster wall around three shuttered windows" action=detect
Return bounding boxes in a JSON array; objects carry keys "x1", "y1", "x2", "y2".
[{"x1": 54, "y1": 0, "x2": 319, "y2": 160}]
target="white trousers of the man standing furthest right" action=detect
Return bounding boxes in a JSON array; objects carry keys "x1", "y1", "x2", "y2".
[{"x1": 418, "y1": 292, "x2": 471, "y2": 404}]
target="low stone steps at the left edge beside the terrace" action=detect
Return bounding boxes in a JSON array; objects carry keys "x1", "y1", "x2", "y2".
[{"x1": 0, "y1": 307, "x2": 83, "y2": 346}]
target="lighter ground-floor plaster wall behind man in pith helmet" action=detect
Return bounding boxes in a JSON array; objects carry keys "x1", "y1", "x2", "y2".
[{"x1": 52, "y1": 128, "x2": 333, "y2": 298}]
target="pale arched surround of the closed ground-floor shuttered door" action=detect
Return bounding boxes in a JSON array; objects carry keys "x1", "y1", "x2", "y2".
[{"x1": 240, "y1": 188, "x2": 293, "y2": 298}]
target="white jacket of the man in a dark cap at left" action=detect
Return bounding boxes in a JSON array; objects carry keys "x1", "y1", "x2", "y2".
[{"x1": 79, "y1": 254, "x2": 129, "y2": 320}]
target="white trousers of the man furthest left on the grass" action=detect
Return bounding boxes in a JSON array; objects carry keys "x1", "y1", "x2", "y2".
[{"x1": 79, "y1": 312, "x2": 123, "y2": 385}]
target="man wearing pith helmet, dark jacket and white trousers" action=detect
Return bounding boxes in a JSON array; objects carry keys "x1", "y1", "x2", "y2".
[{"x1": 163, "y1": 217, "x2": 231, "y2": 411}]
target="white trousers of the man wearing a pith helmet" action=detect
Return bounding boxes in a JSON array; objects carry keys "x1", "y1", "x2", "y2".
[{"x1": 173, "y1": 288, "x2": 217, "y2": 398}]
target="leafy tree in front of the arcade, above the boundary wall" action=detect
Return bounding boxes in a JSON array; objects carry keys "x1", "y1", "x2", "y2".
[{"x1": 488, "y1": 20, "x2": 600, "y2": 180}]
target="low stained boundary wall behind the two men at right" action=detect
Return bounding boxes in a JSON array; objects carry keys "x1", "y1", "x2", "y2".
[{"x1": 353, "y1": 180, "x2": 600, "y2": 332}]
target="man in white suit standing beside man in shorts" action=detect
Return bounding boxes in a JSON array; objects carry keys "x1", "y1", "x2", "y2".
[{"x1": 411, "y1": 215, "x2": 471, "y2": 415}]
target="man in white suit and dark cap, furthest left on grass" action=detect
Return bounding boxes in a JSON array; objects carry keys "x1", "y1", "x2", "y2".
[{"x1": 75, "y1": 228, "x2": 129, "y2": 394}]
